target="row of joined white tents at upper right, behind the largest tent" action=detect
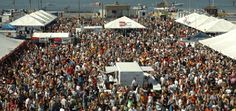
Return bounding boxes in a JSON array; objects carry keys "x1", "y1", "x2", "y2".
[{"x1": 175, "y1": 13, "x2": 236, "y2": 33}]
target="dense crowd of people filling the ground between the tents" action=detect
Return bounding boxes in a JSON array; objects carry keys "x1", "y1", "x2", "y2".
[{"x1": 0, "y1": 14, "x2": 236, "y2": 111}]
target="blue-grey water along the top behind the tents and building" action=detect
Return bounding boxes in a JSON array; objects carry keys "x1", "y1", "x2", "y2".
[{"x1": 0, "y1": 0, "x2": 236, "y2": 13}]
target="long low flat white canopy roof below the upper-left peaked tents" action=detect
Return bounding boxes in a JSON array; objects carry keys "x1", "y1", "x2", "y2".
[{"x1": 32, "y1": 33, "x2": 69, "y2": 38}]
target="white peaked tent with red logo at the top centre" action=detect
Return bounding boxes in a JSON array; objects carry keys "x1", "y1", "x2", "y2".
[{"x1": 105, "y1": 16, "x2": 145, "y2": 29}]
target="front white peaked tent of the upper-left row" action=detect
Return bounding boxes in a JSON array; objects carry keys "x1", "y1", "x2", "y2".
[{"x1": 10, "y1": 14, "x2": 45, "y2": 26}]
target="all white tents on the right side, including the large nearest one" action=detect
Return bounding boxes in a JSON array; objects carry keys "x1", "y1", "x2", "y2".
[{"x1": 175, "y1": 13, "x2": 236, "y2": 60}]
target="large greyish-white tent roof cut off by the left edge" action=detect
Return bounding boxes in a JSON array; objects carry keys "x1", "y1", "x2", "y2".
[{"x1": 0, "y1": 34, "x2": 24, "y2": 59}]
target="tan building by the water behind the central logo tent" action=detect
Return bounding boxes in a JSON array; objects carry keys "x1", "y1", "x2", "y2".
[{"x1": 105, "y1": 2, "x2": 130, "y2": 18}]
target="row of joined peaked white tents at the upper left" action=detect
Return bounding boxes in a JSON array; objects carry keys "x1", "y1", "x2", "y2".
[{"x1": 10, "y1": 10, "x2": 57, "y2": 27}]
